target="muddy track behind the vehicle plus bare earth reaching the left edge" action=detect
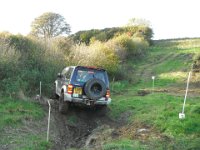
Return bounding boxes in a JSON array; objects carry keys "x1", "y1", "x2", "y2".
[{"x1": 0, "y1": 99, "x2": 118, "y2": 150}]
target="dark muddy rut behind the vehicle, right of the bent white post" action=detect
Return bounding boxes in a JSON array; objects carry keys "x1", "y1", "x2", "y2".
[{"x1": 45, "y1": 100, "x2": 116, "y2": 150}]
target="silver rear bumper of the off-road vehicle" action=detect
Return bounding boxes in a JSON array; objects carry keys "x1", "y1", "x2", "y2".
[{"x1": 64, "y1": 93, "x2": 111, "y2": 105}]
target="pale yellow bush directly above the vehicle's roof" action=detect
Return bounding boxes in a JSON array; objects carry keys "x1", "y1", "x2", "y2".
[{"x1": 70, "y1": 41, "x2": 119, "y2": 74}]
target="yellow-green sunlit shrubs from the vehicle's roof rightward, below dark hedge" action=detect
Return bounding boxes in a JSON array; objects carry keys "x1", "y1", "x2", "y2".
[{"x1": 70, "y1": 34, "x2": 149, "y2": 80}]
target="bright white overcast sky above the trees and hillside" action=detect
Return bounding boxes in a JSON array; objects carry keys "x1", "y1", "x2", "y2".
[{"x1": 0, "y1": 0, "x2": 200, "y2": 39}]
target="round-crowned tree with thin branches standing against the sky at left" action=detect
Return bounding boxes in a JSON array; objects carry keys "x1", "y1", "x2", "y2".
[{"x1": 31, "y1": 12, "x2": 70, "y2": 38}]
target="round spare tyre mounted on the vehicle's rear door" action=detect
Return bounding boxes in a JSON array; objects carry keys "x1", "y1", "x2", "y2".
[{"x1": 84, "y1": 78, "x2": 106, "y2": 100}]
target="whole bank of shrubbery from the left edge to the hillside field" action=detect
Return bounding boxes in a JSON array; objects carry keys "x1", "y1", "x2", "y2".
[{"x1": 0, "y1": 27, "x2": 152, "y2": 96}]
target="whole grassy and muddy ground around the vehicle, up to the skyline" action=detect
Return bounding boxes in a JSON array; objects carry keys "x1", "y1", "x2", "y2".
[{"x1": 0, "y1": 39, "x2": 200, "y2": 150}]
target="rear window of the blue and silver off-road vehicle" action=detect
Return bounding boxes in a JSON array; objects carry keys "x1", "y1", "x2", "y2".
[{"x1": 76, "y1": 69, "x2": 106, "y2": 83}]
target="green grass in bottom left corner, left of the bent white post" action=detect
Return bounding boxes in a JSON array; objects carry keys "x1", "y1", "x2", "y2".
[{"x1": 0, "y1": 98, "x2": 51, "y2": 150}]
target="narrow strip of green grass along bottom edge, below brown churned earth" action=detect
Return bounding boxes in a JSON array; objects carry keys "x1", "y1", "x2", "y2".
[{"x1": 103, "y1": 137, "x2": 200, "y2": 150}]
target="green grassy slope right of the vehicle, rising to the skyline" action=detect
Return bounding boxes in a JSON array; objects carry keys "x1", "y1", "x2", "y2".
[{"x1": 108, "y1": 39, "x2": 200, "y2": 149}]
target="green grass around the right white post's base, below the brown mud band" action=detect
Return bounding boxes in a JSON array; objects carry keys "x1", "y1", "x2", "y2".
[{"x1": 110, "y1": 93, "x2": 200, "y2": 136}]
